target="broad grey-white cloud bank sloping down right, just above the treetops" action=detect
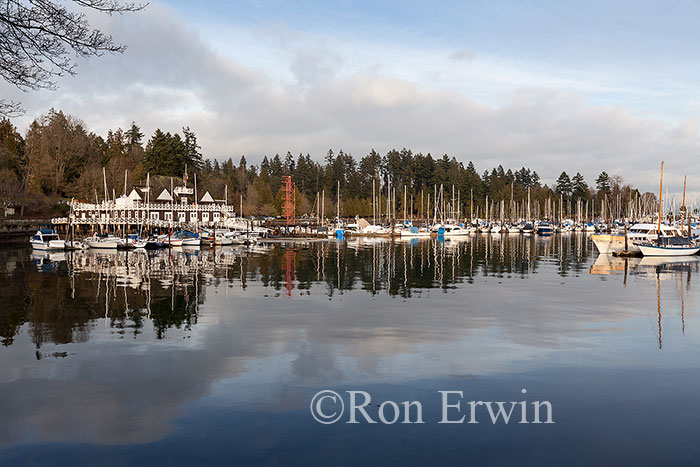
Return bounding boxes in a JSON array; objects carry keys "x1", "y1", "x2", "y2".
[{"x1": 3, "y1": 0, "x2": 700, "y2": 194}]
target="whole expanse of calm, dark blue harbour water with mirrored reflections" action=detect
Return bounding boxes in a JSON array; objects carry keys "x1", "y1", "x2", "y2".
[{"x1": 0, "y1": 234, "x2": 700, "y2": 466}]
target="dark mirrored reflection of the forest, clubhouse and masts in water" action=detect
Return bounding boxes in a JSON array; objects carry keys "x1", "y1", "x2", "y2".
[{"x1": 0, "y1": 235, "x2": 591, "y2": 347}]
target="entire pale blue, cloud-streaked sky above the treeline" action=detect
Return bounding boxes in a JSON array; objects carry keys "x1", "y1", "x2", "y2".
[{"x1": 0, "y1": 0, "x2": 700, "y2": 191}]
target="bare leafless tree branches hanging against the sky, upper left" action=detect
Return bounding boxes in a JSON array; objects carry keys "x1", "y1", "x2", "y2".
[{"x1": 0, "y1": 0, "x2": 146, "y2": 116}]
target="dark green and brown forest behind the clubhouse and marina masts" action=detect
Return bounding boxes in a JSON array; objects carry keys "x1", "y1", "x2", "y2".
[{"x1": 0, "y1": 109, "x2": 653, "y2": 217}]
